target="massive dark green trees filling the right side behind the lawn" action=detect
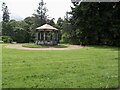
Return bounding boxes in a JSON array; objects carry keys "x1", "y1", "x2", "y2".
[{"x1": 59, "y1": 2, "x2": 120, "y2": 46}]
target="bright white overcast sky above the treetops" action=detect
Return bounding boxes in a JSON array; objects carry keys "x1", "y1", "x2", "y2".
[{"x1": 0, "y1": 0, "x2": 72, "y2": 21}]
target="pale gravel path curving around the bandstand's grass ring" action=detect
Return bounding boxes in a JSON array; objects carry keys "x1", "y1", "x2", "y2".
[{"x1": 5, "y1": 44, "x2": 83, "y2": 50}]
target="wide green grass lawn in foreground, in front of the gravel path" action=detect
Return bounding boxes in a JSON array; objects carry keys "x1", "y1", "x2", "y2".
[{"x1": 2, "y1": 46, "x2": 118, "y2": 88}]
